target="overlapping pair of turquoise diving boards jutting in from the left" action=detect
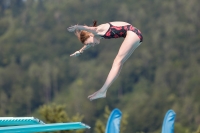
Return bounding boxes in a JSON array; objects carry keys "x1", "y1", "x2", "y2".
[{"x1": 0, "y1": 117, "x2": 90, "y2": 133}]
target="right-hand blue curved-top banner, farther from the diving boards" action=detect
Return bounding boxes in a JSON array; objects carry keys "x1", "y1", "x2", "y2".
[{"x1": 162, "y1": 110, "x2": 176, "y2": 133}]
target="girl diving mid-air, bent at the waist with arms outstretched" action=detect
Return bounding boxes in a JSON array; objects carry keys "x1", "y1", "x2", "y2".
[{"x1": 68, "y1": 21, "x2": 143, "y2": 100}]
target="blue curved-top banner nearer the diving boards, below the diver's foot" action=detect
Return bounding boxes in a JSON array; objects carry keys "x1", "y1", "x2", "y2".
[{"x1": 105, "y1": 109, "x2": 122, "y2": 133}]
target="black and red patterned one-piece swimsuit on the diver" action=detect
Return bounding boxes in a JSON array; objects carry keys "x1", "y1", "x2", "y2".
[{"x1": 101, "y1": 23, "x2": 143, "y2": 42}]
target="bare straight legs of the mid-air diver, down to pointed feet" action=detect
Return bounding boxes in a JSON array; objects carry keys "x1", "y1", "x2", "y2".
[{"x1": 88, "y1": 31, "x2": 140, "y2": 100}]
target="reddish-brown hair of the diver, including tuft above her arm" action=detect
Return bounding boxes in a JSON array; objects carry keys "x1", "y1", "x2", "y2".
[{"x1": 75, "y1": 20, "x2": 97, "y2": 44}]
